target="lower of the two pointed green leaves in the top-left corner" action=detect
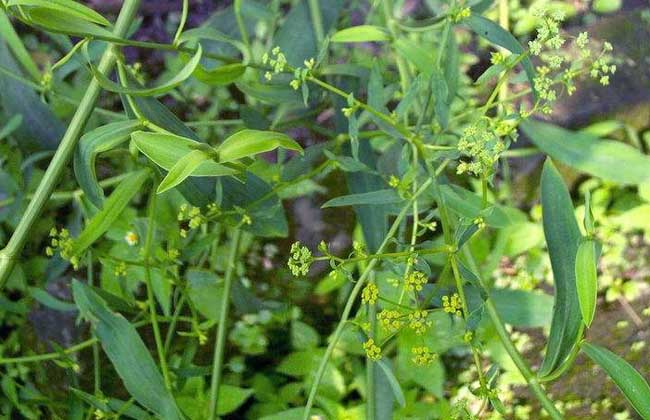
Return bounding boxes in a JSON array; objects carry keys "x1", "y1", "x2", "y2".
[{"x1": 21, "y1": 7, "x2": 117, "y2": 42}]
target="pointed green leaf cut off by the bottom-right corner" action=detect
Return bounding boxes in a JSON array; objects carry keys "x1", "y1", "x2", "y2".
[{"x1": 581, "y1": 342, "x2": 650, "y2": 420}]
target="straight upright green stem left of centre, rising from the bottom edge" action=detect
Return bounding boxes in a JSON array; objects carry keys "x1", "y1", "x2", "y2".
[{"x1": 208, "y1": 228, "x2": 241, "y2": 420}]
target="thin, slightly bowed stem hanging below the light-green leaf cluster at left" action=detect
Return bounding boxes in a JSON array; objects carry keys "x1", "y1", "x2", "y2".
[{"x1": 144, "y1": 182, "x2": 172, "y2": 390}]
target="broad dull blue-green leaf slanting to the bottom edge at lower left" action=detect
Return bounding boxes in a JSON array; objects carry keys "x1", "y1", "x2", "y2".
[{"x1": 72, "y1": 280, "x2": 181, "y2": 420}]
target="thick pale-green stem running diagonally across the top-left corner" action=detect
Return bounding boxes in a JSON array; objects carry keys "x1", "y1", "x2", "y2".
[{"x1": 0, "y1": 0, "x2": 140, "y2": 291}]
